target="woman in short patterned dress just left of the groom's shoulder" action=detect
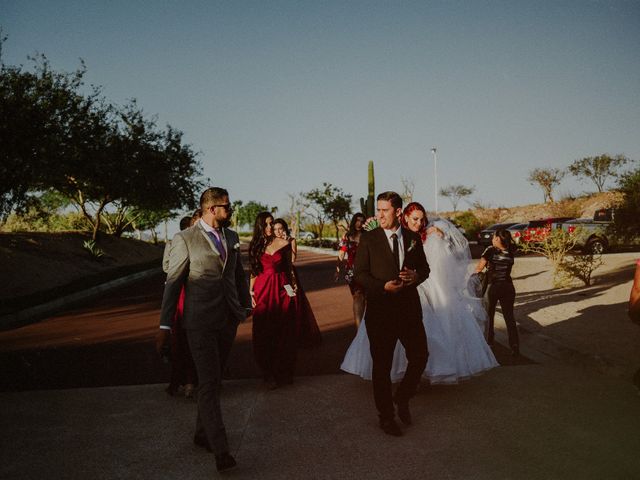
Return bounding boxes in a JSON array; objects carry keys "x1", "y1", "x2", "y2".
[{"x1": 336, "y1": 213, "x2": 365, "y2": 327}]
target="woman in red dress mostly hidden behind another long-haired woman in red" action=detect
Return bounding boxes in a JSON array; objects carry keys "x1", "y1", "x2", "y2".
[{"x1": 273, "y1": 218, "x2": 322, "y2": 348}]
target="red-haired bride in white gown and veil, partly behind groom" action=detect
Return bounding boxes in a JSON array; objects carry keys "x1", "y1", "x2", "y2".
[{"x1": 340, "y1": 202, "x2": 498, "y2": 384}]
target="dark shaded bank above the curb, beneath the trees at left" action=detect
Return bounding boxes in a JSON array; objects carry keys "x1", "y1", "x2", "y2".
[{"x1": 0, "y1": 232, "x2": 163, "y2": 314}]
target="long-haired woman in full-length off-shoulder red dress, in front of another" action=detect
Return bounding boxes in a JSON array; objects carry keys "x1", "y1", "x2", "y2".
[{"x1": 249, "y1": 212, "x2": 297, "y2": 388}]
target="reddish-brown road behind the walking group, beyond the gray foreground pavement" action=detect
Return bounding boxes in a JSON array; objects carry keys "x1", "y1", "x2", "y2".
[{"x1": 0, "y1": 248, "x2": 527, "y2": 391}]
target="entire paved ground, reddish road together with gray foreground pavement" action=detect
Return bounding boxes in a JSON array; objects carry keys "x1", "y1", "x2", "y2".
[{"x1": 0, "y1": 249, "x2": 640, "y2": 480}]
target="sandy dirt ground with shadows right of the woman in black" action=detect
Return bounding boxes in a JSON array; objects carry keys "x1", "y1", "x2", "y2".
[{"x1": 513, "y1": 252, "x2": 640, "y2": 377}]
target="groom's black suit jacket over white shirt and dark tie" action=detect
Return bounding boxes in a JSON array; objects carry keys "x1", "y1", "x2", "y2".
[{"x1": 354, "y1": 228, "x2": 429, "y2": 324}]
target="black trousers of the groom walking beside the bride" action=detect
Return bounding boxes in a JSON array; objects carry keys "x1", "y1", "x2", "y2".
[{"x1": 365, "y1": 308, "x2": 429, "y2": 419}]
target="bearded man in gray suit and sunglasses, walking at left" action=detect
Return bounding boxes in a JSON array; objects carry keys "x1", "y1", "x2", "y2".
[{"x1": 156, "y1": 187, "x2": 251, "y2": 471}]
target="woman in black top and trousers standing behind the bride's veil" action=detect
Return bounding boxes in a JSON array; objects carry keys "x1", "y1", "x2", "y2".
[{"x1": 476, "y1": 228, "x2": 520, "y2": 356}]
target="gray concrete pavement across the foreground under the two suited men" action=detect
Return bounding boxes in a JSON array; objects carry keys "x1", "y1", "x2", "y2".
[{"x1": 0, "y1": 363, "x2": 640, "y2": 480}]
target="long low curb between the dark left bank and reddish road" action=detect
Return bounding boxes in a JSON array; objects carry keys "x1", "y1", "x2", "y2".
[{"x1": 0, "y1": 267, "x2": 162, "y2": 332}]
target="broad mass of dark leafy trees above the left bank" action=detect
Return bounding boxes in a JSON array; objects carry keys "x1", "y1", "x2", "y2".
[{"x1": 0, "y1": 44, "x2": 203, "y2": 239}]
